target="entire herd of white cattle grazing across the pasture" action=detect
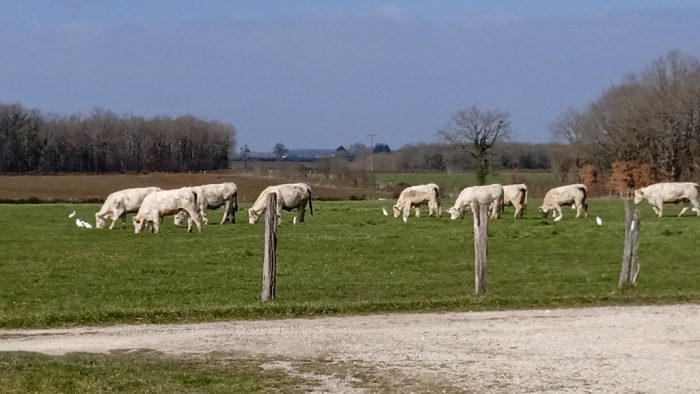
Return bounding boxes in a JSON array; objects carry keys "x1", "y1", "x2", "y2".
[{"x1": 95, "y1": 182, "x2": 700, "y2": 234}]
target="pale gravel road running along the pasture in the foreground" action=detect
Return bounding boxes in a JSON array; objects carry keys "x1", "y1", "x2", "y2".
[{"x1": 0, "y1": 305, "x2": 700, "y2": 393}]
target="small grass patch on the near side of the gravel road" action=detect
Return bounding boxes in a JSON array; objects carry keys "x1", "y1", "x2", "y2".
[{"x1": 0, "y1": 351, "x2": 304, "y2": 393}]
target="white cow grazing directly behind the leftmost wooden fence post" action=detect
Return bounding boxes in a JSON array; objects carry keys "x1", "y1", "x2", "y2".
[{"x1": 248, "y1": 183, "x2": 314, "y2": 224}]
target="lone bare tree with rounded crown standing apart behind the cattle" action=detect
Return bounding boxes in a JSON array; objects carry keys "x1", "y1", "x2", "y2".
[{"x1": 438, "y1": 106, "x2": 511, "y2": 184}]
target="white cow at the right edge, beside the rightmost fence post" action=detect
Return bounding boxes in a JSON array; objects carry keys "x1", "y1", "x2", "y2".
[{"x1": 634, "y1": 182, "x2": 700, "y2": 217}]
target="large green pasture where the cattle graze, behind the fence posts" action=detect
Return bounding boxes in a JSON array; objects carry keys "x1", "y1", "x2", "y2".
[{"x1": 0, "y1": 199, "x2": 700, "y2": 327}]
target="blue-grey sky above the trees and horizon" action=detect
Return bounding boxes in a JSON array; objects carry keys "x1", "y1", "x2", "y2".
[{"x1": 0, "y1": 0, "x2": 700, "y2": 151}]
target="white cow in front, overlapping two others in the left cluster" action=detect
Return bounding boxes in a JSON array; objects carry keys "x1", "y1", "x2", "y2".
[{"x1": 132, "y1": 187, "x2": 202, "y2": 234}]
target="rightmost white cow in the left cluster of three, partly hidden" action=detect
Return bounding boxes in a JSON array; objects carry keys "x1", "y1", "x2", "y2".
[{"x1": 175, "y1": 182, "x2": 238, "y2": 225}]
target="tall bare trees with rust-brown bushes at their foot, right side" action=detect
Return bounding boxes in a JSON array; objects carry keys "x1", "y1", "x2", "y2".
[{"x1": 552, "y1": 51, "x2": 700, "y2": 183}]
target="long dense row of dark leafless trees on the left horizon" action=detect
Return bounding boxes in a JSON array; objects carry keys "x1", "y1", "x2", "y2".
[{"x1": 0, "y1": 104, "x2": 236, "y2": 173}]
